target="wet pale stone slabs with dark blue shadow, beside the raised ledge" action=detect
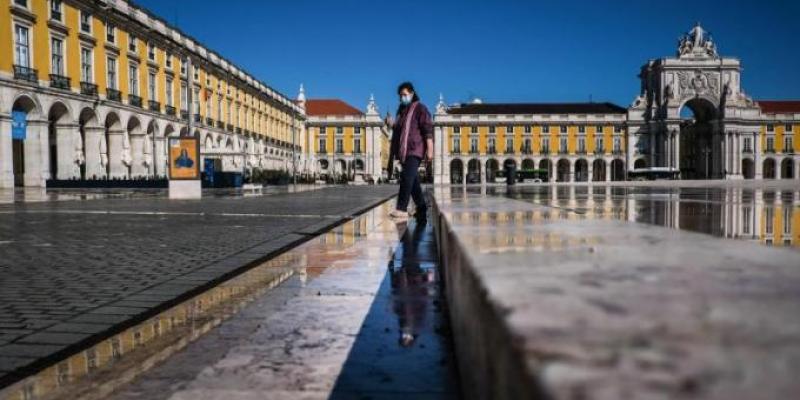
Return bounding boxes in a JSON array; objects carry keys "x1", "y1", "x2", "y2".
[{"x1": 101, "y1": 203, "x2": 460, "y2": 400}]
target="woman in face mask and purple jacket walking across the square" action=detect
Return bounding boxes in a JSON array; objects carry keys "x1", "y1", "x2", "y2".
[{"x1": 386, "y1": 82, "x2": 433, "y2": 219}]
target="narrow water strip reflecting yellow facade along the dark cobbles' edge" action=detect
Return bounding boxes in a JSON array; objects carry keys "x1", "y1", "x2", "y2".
[{"x1": 0, "y1": 203, "x2": 388, "y2": 400}]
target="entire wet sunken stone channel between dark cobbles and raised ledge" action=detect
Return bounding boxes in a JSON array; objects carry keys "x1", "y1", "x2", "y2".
[{"x1": 0, "y1": 202, "x2": 457, "y2": 400}]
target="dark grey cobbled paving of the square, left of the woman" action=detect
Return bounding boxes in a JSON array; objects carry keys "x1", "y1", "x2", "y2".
[{"x1": 0, "y1": 186, "x2": 397, "y2": 387}]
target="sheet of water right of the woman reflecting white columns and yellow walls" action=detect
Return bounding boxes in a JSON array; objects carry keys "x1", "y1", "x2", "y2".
[{"x1": 451, "y1": 186, "x2": 800, "y2": 249}]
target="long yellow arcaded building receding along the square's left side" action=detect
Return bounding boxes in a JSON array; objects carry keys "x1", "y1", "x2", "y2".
[{"x1": 0, "y1": 0, "x2": 308, "y2": 188}]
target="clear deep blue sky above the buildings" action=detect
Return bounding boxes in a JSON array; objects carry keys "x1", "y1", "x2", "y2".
[{"x1": 136, "y1": 0, "x2": 800, "y2": 113}]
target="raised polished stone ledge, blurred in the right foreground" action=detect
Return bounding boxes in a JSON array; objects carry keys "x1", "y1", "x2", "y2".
[{"x1": 434, "y1": 188, "x2": 800, "y2": 400}]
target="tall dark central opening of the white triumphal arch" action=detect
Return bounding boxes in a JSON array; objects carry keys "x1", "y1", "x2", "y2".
[{"x1": 679, "y1": 98, "x2": 725, "y2": 179}]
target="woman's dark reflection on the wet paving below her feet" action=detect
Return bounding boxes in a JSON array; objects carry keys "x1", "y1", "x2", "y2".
[{"x1": 390, "y1": 222, "x2": 435, "y2": 347}]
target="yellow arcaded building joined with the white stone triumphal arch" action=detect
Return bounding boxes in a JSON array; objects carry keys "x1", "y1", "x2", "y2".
[{"x1": 434, "y1": 25, "x2": 800, "y2": 183}]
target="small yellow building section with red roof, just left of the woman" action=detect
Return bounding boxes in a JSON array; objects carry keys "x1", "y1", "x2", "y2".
[{"x1": 297, "y1": 87, "x2": 389, "y2": 181}]
